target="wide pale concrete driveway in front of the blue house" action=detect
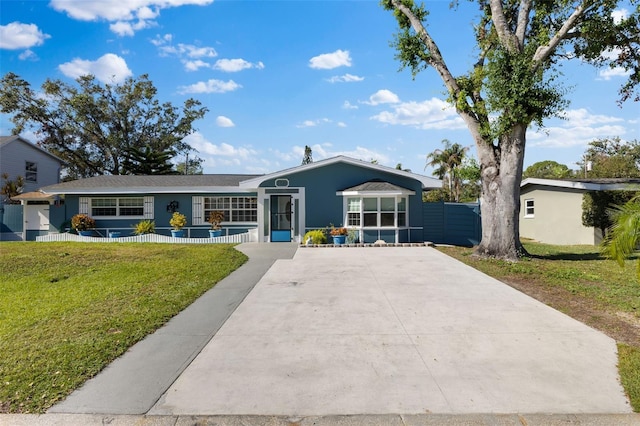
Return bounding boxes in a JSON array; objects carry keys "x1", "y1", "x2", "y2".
[{"x1": 148, "y1": 247, "x2": 631, "y2": 416}]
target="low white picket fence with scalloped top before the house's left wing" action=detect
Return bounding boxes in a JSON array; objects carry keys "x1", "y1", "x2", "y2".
[{"x1": 36, "y1": 230, "x2": 258, "y2": 244}]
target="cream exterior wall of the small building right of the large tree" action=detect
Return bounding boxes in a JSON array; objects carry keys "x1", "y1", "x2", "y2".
[{"x1": 520, "y1": 186, "x2": 602, "y2": 245}]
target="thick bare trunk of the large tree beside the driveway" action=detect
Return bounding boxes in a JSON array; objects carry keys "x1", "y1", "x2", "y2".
[{"x1": 476, "y1": 124, "x2": 527, "y2": 260}]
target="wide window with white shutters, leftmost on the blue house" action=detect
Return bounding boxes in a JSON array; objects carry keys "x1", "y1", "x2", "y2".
[{"x1": 79, "y1": 197, "x2": 153, "y2": 219}]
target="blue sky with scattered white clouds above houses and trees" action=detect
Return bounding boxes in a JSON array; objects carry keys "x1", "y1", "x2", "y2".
[{"x1": 0, "y1": 0, "x2": 640, "y2": 174}]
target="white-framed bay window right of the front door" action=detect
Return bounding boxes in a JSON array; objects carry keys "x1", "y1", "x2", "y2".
[{"x1": 345, "y1": 196, "x2": 407, "y2": 228}]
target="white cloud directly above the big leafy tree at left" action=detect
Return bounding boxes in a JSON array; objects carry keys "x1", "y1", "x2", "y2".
[{"x1": 58, "y1": 53, "x2": 133, "y2": 83}]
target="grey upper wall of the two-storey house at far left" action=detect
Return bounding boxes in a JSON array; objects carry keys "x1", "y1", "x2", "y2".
[{"x1": 0, "y1": 140, "x2": 60, "y2": 192}]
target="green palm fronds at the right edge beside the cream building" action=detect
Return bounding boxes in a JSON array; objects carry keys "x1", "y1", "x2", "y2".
[{"x1": 602, "y1": 195, "x2": 640, "y2": 280}]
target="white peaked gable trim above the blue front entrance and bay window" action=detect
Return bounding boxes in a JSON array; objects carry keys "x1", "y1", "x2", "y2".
[{"x1": 240, "y1": 155, "x2": 442, "y2": 189}]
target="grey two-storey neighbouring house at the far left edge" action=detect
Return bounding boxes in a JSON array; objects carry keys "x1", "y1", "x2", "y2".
[{"x1": 0, "y1": 136, "x2": 63, "y2": 240}]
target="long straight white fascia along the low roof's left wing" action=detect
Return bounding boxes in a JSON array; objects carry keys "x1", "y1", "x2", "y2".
[{"x1": 41, "y1": 186, "x2": 257, "y2": 196}]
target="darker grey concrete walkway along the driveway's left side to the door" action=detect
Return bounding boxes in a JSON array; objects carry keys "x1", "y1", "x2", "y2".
[{"x1": 49, "y1": 243, "x2": 297, "y2": 414}]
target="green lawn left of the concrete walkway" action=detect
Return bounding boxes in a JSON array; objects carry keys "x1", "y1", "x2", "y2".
[{"x1": 0, "y1": 242, "x2": 247, "y2": 413}]
